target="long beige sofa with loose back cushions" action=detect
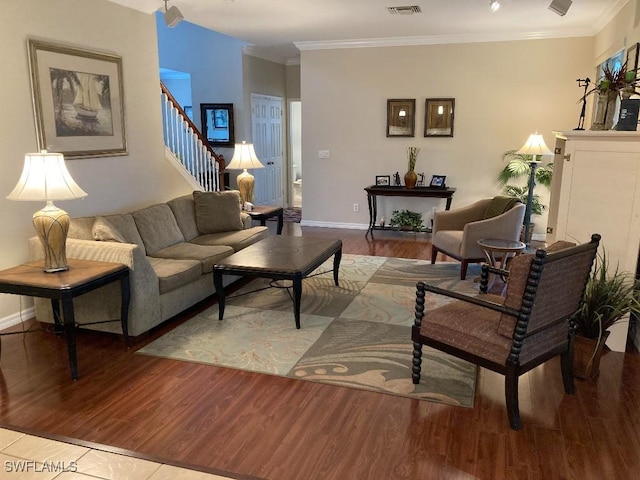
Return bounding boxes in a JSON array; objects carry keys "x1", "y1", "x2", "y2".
[{"x1": 29, "y1": 191, "x2": 268, "y2": 337}]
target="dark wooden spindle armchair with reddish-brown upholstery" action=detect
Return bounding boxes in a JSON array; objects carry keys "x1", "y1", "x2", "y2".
[{"x1": 411, "y1": 234, "x2": 600, "y2": 430}]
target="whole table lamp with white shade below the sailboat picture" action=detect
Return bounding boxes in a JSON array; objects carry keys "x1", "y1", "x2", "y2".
[{"x1": 7, "y1": 150, "x2": 87, "y2": 273}]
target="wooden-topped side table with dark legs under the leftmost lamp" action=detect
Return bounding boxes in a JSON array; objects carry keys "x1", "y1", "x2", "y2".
[{"x1": 0, "y1": 259, "x2": 131, "y2": 380}]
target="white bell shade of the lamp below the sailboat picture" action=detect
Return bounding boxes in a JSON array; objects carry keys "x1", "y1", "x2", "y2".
[{"x1": 7, "y1": 151, "x2": 87, "y2": 201}]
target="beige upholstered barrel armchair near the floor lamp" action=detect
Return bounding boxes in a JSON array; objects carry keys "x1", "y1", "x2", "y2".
[{"x1": 431, "y1": 196, "x2": 526, "y2": 280}]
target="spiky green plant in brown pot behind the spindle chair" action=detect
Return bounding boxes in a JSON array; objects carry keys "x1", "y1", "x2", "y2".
[{"x1": 573, "y1": 253, "x2": 640, "y2": 378}]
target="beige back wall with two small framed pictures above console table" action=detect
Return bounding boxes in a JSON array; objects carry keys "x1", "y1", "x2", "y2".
[{"x1": 301, "y1": 38, "x2": 593, "y2": 232}]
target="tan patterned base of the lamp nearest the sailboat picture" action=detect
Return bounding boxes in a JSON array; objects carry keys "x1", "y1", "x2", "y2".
[{"x1": 33, "y1": 201, "x2": 69, "y2": 273}]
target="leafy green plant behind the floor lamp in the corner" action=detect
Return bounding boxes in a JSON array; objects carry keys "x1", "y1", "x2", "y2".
[{"x1": 498, "y1": 150, "x2": 553, "y2": 241}]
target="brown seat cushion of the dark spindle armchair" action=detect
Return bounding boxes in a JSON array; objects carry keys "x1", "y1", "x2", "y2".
[{"x1": 420, "y1": 295, "x2": 511, "y2": 365}]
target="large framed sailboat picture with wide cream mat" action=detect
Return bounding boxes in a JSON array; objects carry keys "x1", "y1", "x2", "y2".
[{"x1": 28, "y1": 39, "x2": 127, "y2": 158}]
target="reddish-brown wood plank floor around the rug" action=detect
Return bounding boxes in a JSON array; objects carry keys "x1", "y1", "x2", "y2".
[{"x1": 0, "y1": 222, "x2": 640, "y2": 480}]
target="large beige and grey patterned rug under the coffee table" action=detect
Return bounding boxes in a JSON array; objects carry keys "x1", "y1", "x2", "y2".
[{"x1": 137, "y1": 255, "x2": 479, "y2": 407}]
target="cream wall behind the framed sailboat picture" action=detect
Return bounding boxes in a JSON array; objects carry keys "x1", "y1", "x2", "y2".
[{"x1": 0, "y1": 0, "x2": 190, "y2": 319}]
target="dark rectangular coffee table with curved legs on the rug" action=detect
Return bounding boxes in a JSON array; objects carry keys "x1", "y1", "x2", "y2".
[{"x1": 213, "y1": 236, "x2": 342, "y2": 328}]
